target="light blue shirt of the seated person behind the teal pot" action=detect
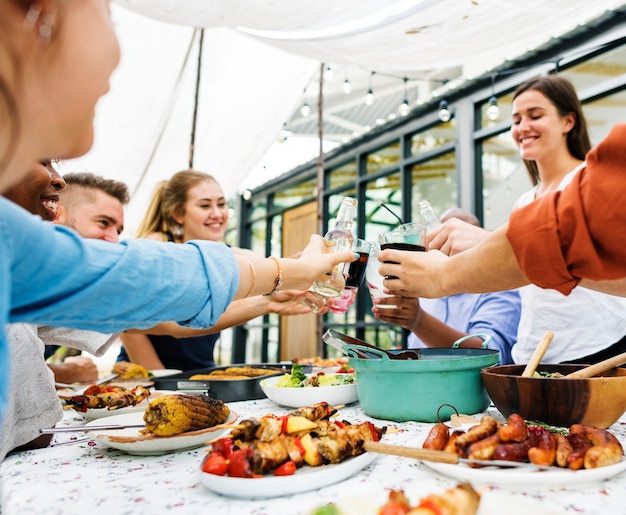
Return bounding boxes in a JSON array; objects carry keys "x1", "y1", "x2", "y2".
[{"x1": 407, "y1": 290, "x2": 521, "y2": 365}]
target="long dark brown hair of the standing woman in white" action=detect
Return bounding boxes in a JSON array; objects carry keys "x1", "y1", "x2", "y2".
[{"x1": 513, "y1": 75, "x2": 591, "y2": 186}]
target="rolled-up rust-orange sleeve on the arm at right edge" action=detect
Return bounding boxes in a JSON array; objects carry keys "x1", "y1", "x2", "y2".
[{"x1": 507, "y1": 124, "x2": 626, "y2": 294}]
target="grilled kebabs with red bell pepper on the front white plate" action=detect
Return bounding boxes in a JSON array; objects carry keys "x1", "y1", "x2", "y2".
[{"x1": 202, "y1": 403, "x2": 386, "y2": 477}]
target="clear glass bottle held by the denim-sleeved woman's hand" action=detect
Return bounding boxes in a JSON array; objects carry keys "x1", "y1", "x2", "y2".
[{"x1": 313, "y1": 197, "x2": 356, "y2": 298}]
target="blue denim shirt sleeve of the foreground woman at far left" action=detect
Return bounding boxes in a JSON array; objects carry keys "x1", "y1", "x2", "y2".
[{"x1": 0, "y1": 197, "x2": 239, "y2": 417}]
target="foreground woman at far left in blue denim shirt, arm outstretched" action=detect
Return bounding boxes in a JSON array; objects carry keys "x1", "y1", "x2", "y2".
[{"x1": 0, "y1": 0, "x2": 355, "y2": 422}]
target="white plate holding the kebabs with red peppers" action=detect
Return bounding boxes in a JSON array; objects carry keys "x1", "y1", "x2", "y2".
[{"x1": 200, "y1": 452, "x2": 378, "y2": 499}]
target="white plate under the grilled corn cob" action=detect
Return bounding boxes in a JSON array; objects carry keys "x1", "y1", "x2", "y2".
[{"x1": 85, "y1": 411, "x2": 238, "y2": 456}]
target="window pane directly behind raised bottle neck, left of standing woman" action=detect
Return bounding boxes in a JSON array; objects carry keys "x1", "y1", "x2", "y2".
[{"x1": 411, "y1": 152, "x2": 458, "y2": 219}]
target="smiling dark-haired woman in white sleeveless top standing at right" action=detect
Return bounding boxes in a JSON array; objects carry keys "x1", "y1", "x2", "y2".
[{"x1": 428, "y1": 75, "x2": 626, "y2": 363}]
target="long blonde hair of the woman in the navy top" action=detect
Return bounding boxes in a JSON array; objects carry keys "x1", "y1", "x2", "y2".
[{"x1": 137, "y1": 170, "x2": 217, "y2": 241}]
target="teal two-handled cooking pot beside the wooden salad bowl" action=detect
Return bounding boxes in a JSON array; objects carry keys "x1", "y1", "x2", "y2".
[{"x1": 343, "y1": 334, "x2": 500, "y2": 422}]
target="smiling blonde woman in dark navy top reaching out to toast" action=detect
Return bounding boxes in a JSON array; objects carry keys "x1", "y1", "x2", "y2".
[{"x1": 117, "y1": 170, "x2": 310, "y2": 371}]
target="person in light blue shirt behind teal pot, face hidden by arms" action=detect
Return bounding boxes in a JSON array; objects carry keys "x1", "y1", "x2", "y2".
[{"x1": 372, "y1": 208, "x2": 521, "y2": 365}]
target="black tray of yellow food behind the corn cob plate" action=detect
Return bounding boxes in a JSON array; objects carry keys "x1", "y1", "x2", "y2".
[{"x1": 153, "y1": 363, "x2": 312, "y2": 402}]
